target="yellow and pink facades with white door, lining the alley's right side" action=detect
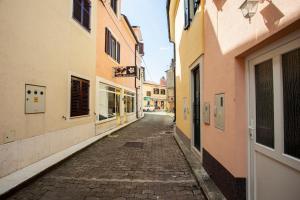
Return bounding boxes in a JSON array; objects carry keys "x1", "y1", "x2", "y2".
[{"x1": 167, "y1": 0, "x2": 300, "y2": 200}]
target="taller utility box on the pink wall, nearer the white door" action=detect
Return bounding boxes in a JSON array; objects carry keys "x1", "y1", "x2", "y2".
[{"x1": 215, "y1": 93, "x2": 225, "y2": 130}]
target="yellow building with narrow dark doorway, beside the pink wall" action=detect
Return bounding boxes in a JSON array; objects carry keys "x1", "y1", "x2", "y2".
[{"x1": 167, "y1": 0, "x2": 204, "y2": 152}]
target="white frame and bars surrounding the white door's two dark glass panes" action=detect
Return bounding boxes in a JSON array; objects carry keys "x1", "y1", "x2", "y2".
[{"x1": 245, "y1": 31, "x2": 300, "y2": 200}]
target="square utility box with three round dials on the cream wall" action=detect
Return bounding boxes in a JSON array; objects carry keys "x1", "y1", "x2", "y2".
[{"x1": 25, "y1": 84, "x2": 46, "y2": 114}]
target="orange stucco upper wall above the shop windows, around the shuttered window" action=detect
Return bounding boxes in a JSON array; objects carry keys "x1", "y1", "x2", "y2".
[{"x1": 96, "y1": 1, "x2": 136, "y2": 89}]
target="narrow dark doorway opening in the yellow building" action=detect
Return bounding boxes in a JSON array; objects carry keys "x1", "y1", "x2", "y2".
[{"x1": 192, "y1": 66, "x2": 201, "y2": 151}]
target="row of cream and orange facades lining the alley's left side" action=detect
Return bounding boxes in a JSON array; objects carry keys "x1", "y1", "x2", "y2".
[{"x1": 0, "y1": 0, "x2": 144, "y2": 181}]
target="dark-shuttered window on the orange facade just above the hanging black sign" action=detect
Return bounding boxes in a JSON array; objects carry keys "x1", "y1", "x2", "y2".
[{"x1": 105, "y1": 28, "x2": 121, "y2": 63}]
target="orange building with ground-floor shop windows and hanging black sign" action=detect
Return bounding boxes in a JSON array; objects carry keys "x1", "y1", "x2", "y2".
[{"x1": 96, "y1": 0, "x2": 143, "y2": 134}]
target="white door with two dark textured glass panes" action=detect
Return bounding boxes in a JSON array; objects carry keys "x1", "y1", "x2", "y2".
[{"x1": 248, "y1": 37, "x2": 300, "y2": 200}]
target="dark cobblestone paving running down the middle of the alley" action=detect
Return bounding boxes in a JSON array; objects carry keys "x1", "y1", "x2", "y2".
[{"x1": 8, "y1": 115, "x2": 205, "y2": 200}]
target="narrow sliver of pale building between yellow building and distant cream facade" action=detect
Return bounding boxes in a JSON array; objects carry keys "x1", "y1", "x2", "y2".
[{"x1": 166, "y1": 59, "x2": 175, "y2": 112}]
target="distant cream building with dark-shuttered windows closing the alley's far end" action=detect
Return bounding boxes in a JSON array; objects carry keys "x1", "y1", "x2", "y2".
[{"x1": 143, "y1": 81, "x2": 167, "y2": 111}]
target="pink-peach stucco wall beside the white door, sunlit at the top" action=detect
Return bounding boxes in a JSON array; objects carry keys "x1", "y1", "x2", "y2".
[{"x1": 203, "y1": 0, "x2": 300, "y2": 177}]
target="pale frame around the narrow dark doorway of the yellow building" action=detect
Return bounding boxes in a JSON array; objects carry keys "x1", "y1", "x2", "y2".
[{"x1": 189, "y1": 55, "x2": 203, "y2": 158}]
